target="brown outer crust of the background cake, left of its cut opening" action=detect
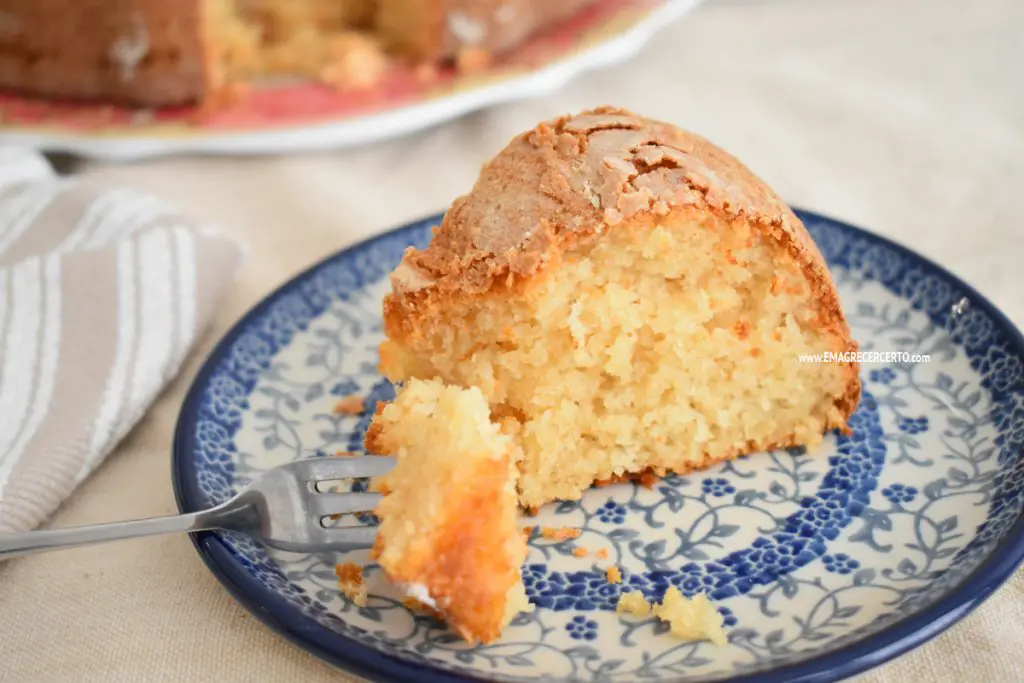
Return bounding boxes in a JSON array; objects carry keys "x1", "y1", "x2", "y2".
[{"x1": 0, "y1": 0, "x2": 208, "y2": 106}]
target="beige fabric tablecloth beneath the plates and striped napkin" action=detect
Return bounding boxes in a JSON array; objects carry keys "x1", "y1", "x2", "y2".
[{"x1": 0, "y1": 0, "x2": 1024, "y2": 683}]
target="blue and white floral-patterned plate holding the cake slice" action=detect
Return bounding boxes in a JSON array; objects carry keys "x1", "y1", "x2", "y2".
[{"x1": 174, "y1": 213, "x2": 1024, "y2": 683}]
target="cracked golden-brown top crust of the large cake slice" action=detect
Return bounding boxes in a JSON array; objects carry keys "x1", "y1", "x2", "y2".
[{"x1": 384, "y1": 106, "x2": 860, "y2": 426}]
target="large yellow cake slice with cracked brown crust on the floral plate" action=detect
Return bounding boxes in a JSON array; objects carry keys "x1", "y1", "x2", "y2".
[{"x1": 381, "y1": 108, "x2": 860, "y2": 507}]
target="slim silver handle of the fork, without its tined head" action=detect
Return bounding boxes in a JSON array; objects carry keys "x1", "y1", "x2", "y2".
[{"x1": 0, "y1": 505, "x2": 249, "y2": 561}]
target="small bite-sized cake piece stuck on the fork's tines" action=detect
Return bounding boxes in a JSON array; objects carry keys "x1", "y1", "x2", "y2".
[{"x1": 368, "y1": 380, "x2": 530, "y2": 643}]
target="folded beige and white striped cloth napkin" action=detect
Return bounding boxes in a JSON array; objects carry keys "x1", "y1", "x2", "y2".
[{"x1": 0, "y1": 147, "x2": 243, "y2": 531}]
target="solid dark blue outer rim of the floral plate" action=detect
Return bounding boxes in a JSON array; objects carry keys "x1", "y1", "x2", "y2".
[{"x1": 171, "y1": 209, "x2": 1024, "y2": 683}]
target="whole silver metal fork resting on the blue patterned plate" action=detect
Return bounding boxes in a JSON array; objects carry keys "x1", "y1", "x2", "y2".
[{"x1": 0, "y1": 456, "x2": 394, "y2": 560}]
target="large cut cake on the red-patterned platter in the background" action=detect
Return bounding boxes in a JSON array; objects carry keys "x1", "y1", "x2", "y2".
[{"x1": 0, "y1": 0, "x2": 595, "y2": 106}]
